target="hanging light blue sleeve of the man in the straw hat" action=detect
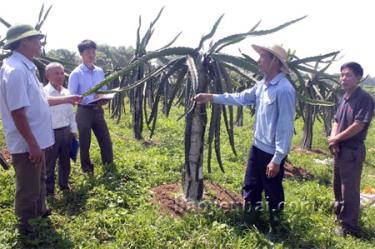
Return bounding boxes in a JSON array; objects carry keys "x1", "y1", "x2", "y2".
[{"x1": 272, "y1": 88, "x2": 295, "y2": 164}]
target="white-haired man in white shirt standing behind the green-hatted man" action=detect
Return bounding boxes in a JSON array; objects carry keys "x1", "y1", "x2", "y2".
[{"x1": 43, "y1": 62, "x2": 77, "y2": 195}]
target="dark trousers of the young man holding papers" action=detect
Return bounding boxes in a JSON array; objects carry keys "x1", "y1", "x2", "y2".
[{"x1": 76, "y1": 106, "x2": 113, "y2": 172}]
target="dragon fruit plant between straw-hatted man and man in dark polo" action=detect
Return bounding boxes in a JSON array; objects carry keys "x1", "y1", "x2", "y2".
[{"x1": 288, "y1": 52, "x2": 340, "y2": 150}]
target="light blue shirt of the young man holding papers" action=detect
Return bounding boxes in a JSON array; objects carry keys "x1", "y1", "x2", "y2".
[{"x1": 68, "y1": 64, "x2": 107, "y2": 105}]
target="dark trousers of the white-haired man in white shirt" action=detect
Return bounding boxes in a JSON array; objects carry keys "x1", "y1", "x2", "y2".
[{"x1": 46, "y1": 127, "x2": 72, "y2": 194}]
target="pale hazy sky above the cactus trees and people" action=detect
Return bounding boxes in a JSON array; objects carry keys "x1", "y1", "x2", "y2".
[{"x1": 0, "y1": 0, "x2": 375, "y2": 76}]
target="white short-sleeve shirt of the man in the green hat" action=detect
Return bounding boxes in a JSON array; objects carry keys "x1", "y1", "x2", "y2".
[{"x1": 0, "y1": 51, "x2": 54, "y2": 154}]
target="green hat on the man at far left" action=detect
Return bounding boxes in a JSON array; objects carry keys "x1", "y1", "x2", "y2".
[{"x1": 3, "y1": 24, "x2": 44, "y2": 49}]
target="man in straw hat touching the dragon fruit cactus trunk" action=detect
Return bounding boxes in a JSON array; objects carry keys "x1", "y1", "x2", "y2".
[{"x1": 194, "y1": 45, "x2": 295, "y2": 238}]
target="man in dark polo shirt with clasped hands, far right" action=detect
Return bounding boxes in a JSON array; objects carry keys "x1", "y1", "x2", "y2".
[{"x1": 328, "y1": 62, "x2": 374, "y2": 236}]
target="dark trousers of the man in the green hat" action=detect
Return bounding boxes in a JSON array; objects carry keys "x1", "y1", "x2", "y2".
[{"x1": 12, "y1": 152, "x2": 47, "y2": 226}]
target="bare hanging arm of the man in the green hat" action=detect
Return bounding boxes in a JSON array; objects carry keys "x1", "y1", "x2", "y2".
[{"x1": 11, "y1": 108, "x2": 43, "y2": 164}]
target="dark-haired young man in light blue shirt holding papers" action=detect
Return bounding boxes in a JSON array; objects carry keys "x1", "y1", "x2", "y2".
[{"x1": 68, "y1": 40, "x2": 113, "y2": 175}]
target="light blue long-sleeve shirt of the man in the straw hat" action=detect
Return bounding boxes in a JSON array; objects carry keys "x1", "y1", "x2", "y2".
[{"x1": 213, "y1": 73, "x2": 296, "y2": 164}]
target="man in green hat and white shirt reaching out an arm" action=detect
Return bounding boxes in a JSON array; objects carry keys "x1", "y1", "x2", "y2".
[{"x1": 0, "y1": 24, "x2": 81, "y2": 233}]
